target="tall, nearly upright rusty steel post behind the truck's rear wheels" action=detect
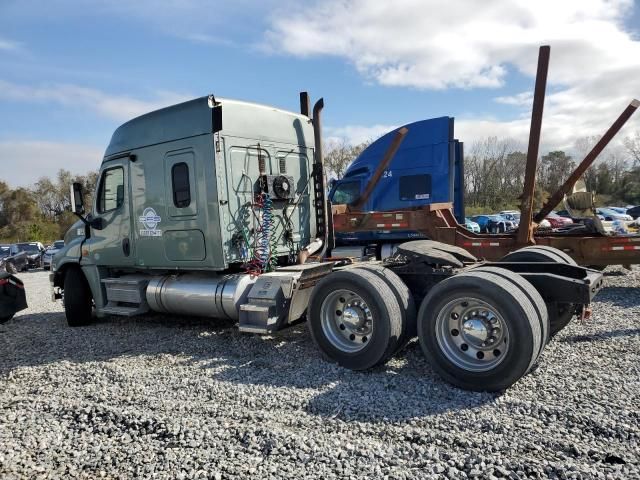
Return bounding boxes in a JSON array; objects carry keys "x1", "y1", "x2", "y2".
[{"x1": 517, "y1": 45, "x2": 551, "y2": 245}]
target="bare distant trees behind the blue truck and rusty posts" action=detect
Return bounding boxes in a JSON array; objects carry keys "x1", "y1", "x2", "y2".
[{"x1": 325, "y1": 132, "x2": 640, "y2": 213}]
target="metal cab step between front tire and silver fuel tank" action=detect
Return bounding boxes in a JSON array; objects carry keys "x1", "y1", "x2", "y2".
[{"x1": 101, "y1": 275, "x2": 149, "y2": 317}]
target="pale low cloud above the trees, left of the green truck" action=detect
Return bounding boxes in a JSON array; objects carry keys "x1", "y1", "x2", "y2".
[{"x1": 0, "y1": 141, "x2": 104, "y2": 188}]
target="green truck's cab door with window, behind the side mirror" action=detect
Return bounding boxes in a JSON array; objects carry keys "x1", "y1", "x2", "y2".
[{"x1": 83, "y1": 158, "x2": 134, "y2": 267}]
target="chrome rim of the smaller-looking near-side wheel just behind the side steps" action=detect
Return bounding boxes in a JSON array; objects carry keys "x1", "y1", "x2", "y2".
[{"x1": 320, "y1": 289, "x2": 373, "y2": 353}]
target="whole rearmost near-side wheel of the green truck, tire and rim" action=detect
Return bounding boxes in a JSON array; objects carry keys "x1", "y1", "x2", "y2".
[{"x1": 418, "y1": 272, "x2": 542, "y2": 392}]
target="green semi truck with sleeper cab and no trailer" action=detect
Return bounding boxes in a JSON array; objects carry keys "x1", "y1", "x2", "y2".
[{"x1": 51, "y1": 92, "x2": 602, "y2": 391}]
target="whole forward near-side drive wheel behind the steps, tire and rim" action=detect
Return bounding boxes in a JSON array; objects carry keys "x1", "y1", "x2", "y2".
[{"x1": 308, "y1": 268, "x2": 402, "y2": 370}]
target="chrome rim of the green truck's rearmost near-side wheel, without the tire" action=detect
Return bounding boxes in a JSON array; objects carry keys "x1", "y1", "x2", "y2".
[{"x1": 436, "y1": 298, "x2": 510, "y2": 372}]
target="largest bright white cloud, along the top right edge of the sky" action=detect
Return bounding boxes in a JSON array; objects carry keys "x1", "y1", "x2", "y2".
[{"x1": 267, "y1": 0, "x2": 640, "y2": 89}]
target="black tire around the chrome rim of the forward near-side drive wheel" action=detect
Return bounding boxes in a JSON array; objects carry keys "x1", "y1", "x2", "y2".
[{"x1": 307, "y1": 268, "x2": 402, "y2": 370}]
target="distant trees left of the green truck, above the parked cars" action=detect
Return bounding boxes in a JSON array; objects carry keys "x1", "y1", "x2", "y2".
[{"x1": 0, "y1": 169, "x2": 98, "y2": 243}]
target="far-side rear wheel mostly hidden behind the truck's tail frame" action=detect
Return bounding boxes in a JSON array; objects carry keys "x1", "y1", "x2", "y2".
[{"x1": 500, "y1": 245, "x2": 577, "y2": 338}]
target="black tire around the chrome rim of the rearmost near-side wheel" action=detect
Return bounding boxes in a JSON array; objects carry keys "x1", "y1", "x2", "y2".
[{"x1": 418, "y1": 272, "x2": 542, "y2": 392}]
